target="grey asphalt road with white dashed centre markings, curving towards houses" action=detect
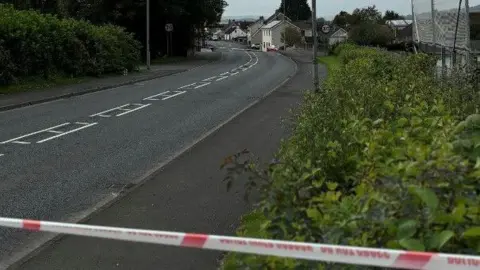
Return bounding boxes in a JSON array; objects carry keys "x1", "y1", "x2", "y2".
[{"x1": 0, "y1": 41, "x2": 295, "y2": 263}]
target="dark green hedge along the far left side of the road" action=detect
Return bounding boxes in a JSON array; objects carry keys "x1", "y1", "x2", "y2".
[{"x1": 0, "y1": 5, "x2": 140, "y2": 85}]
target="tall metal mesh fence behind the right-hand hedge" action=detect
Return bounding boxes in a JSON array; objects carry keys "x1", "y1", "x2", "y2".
[{"x1": 411, "y1": 0, "x2": 480, "y2": 77}]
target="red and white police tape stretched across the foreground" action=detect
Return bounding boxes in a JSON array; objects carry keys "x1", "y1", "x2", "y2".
[{"x1": 0, "y1": 217, "x2": 480, "y2": 270}]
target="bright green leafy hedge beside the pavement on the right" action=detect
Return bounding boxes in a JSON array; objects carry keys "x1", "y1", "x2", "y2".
[{"x1": 223, "y1": 45, "x2": 480, "y2": 269}]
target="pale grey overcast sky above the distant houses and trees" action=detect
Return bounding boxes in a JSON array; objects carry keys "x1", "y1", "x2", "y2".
[{"x1": 224, "y1": 0, "x2": 480, "y2": 18}]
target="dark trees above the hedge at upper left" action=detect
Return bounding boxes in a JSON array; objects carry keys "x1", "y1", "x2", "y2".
[{"x1": 0, "y1": 0, "x2": 227, "y2": 56}]
